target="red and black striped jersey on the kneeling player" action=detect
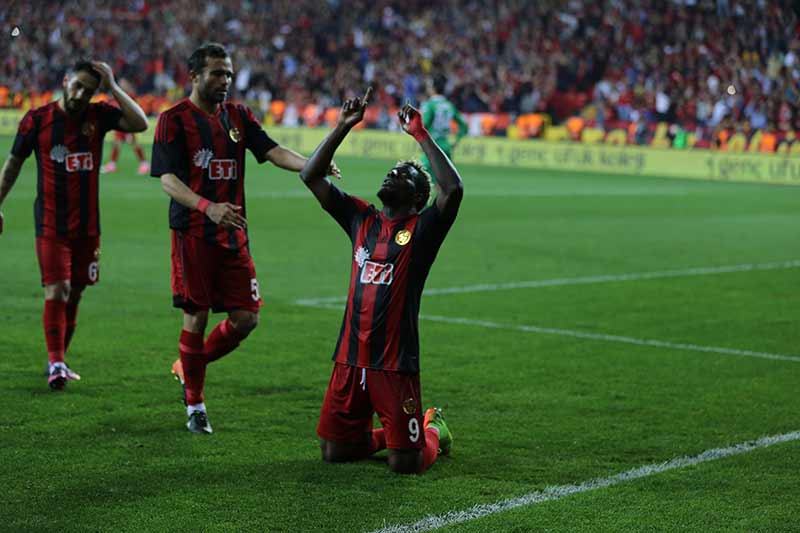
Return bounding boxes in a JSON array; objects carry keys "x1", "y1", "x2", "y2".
[{"x1": 328, "y1": 186, "x2": 457, "y2": 374}]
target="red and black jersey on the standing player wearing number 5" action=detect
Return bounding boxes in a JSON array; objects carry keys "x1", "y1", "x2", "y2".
[{"x1": 150, "y1": 98, "x2": 277, "y2": 250}]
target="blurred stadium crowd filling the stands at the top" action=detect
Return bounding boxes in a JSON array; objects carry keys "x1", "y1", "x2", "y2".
[{"x1": 0, "y1": 0, "x2": 800, "y2": 145}]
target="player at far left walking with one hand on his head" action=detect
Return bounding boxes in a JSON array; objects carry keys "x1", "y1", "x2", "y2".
[{"x1": 0, "y1": 60, "x2": 147, "y2": 390}]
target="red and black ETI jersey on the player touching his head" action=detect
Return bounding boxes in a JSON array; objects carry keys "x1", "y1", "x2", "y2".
[{"x1": 11, "y1": 101, "x2": 122, "y2": 239}]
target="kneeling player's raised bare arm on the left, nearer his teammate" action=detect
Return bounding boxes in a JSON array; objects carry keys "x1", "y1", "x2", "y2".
[{"x1": 300, "y1": 87, "x2": 372, "y2": 209}]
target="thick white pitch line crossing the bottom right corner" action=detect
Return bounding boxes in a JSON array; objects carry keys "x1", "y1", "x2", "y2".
[{"x1": 373, "y1": 431, "x2": 800, "y2": 533}]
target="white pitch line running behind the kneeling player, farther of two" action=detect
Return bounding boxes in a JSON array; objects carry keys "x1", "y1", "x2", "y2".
[{"x1": 295, "y1": 259, "x2": 800, "y2": 305}]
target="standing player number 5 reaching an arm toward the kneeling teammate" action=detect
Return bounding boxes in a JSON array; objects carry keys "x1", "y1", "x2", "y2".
[{"x1": 150, "y1": 43, "x2": 339, "y2": 434}]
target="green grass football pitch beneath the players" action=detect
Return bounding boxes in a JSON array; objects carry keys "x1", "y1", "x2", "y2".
[{"x1": 0, "y1": 137, "x2": 800, "y2": 531}]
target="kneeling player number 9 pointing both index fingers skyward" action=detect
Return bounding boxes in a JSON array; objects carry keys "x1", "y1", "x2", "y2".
[{"x1": 300, "y1": 89, "x2": 463, "y2": 474}]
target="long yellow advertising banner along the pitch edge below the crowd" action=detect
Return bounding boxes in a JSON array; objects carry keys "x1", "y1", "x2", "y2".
[{"x1": 0, "y1": 110, "x2": 800, "y2": 185}]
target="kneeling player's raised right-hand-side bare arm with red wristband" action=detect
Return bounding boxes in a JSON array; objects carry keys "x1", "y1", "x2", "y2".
[{"x1": 397, "y1": 104, "x2": 464, "y2": 212}]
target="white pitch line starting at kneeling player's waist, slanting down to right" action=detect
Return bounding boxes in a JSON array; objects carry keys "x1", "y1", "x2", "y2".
[{"x1": 420, "y1": 315, "x2": 800, "y2": 363}]
